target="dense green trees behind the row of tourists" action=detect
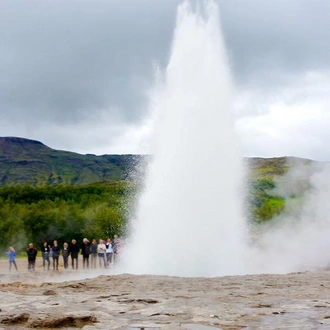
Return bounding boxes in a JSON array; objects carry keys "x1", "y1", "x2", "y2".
[{"x1": 0, "y1": 181, "x2": 137, "y2": 251}]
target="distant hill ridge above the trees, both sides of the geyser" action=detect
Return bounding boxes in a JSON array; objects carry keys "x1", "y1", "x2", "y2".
[{"x1": 0, "y1": 137, "x2": 317, "y2": 186}]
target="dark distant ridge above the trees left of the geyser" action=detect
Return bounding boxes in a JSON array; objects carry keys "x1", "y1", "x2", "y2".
[{"x1": 0, "y1": 137, "x2": 143, "y2": 186}]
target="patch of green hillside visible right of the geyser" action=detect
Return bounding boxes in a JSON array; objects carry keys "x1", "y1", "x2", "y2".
[{"x1": 246, "y1": 157, "x2": 320, "y2": 224}]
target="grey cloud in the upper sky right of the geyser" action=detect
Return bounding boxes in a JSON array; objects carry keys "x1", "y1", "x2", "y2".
[{"x1": 221, "y1": 0, "x2": 330, "y2": 85}]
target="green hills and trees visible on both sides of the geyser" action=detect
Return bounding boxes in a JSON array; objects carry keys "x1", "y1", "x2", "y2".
[{"x1": 0, "y1": 137, "x2": 324, "y2": 249}]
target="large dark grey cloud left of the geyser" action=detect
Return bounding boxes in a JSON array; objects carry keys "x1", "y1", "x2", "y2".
[{"x1": 0, "y1": 0, "x2": 180, "y2": 125}]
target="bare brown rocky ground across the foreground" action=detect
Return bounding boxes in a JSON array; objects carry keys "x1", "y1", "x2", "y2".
[{"x1": 0, "y1": 258, "x2": 330, "y2": 330}]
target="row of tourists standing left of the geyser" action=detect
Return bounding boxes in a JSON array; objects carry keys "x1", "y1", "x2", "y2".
[{"x1": 7, "y1": 235, "x2": 122, "y2": 271}]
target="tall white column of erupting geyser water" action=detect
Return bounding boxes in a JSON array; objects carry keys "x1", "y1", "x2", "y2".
[{"x1": 123, "y1": 1, "x2": 246, "y2": 276}]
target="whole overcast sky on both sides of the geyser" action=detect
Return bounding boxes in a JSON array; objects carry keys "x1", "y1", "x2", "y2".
[{"x1": 0, "y1": 0, "x2": 330, "y2": 161}]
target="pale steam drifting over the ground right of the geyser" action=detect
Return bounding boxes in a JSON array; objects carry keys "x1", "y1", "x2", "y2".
[{"x1": 253, "y1": 162, "x2": 330, "y2": 273}]
